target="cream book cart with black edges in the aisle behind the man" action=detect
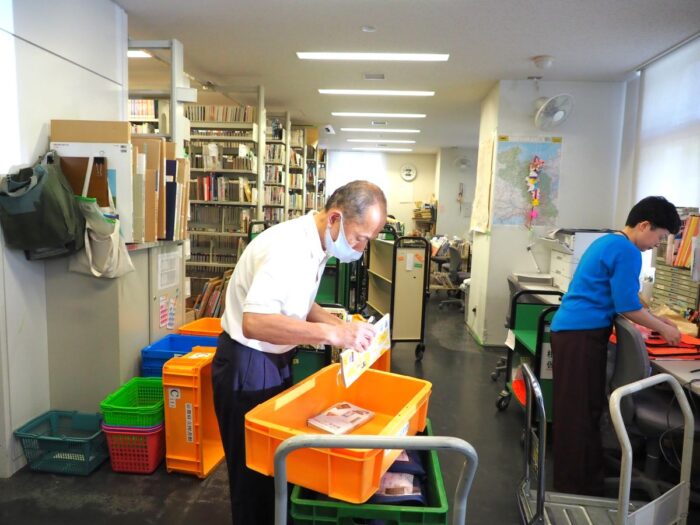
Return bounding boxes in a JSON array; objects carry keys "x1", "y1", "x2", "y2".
[{"x1": 367, "y1": 227, "x2": 430, "y2": 361}]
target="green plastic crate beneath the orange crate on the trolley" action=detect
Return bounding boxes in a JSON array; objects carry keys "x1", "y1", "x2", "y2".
[{"x1": 291, "y1": 420, "x2": 448, "y2": 525}]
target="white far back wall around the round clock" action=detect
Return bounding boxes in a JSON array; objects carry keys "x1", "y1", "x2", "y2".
[{"x1": 326, "y1": 151, "x2": 437, "y2": 228}]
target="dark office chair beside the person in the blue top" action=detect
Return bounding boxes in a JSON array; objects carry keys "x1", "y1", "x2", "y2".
[{"x1": 605, "y1": 316, "x2": 700, "y2": 503}]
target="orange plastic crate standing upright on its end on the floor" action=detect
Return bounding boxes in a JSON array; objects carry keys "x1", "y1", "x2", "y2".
[{"x1": 163, "y1": 346, "x2": 224, "y2": 478}]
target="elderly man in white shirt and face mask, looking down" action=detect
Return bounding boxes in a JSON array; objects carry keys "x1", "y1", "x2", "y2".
[{"x1": 212, "y1": 181, "x2": 387, "y2": 525}]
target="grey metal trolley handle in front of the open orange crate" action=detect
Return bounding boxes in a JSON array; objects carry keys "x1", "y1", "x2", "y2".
[{"x1": 274, "y1": 434, "x2": 479, "y2": 525}]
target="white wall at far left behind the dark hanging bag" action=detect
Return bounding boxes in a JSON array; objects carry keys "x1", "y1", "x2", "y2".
[{"x1": 0, "y1": 0, "x2": 127, "y2": 476}]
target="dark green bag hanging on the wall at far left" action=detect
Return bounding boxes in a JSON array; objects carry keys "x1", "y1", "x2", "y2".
[{"x1": 0, "y1": 152, "x2": 85, "y2": 260}]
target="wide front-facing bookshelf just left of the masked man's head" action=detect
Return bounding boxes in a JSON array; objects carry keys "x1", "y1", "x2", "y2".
[{"x1": 185, "y1": 104, "x2": 262, "y2": 294}]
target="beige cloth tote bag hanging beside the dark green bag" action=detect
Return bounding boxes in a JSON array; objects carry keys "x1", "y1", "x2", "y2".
[{"x1": 68, "y1": 158, "x2": 134, "y2": 279}]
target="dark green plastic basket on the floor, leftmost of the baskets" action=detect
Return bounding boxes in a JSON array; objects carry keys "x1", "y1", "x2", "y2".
[{"x1": 15, "y1": 410, "x2": 109, "y2": 476}]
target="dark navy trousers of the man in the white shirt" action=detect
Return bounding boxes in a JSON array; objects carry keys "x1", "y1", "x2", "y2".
[{"x1": 212, "y1": 332, "x2": 293, "y2": 525}]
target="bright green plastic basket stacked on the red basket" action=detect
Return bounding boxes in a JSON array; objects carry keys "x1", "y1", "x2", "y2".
[{"x1": 100, "y1": 377, "x2": 163, "y2": 427}]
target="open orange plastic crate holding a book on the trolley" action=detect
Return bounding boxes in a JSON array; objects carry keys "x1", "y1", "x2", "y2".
[{"x1": 245, "y1": 364, "x2": 432, "y2": 503}]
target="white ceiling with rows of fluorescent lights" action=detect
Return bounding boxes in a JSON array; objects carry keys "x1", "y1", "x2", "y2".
[{"x1": 116, "y1": 0, "x2": 700, "y2": 152}]
